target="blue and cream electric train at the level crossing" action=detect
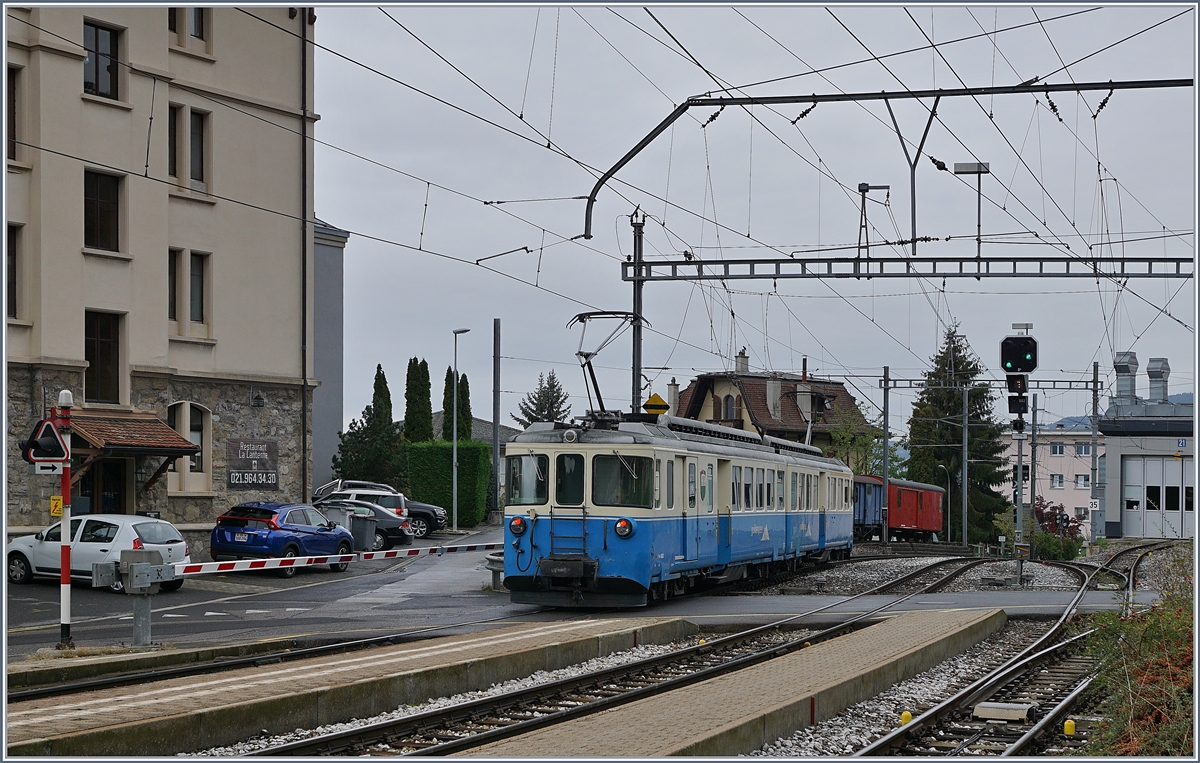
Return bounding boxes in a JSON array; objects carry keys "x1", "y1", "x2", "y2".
[{"x1": 504, "y1": 414, "x2": 854, "y2": 607}]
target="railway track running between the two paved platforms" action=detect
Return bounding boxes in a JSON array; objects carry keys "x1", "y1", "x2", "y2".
[{"x1": 250, "y1": 560, "x2": 974, "y2": 756}]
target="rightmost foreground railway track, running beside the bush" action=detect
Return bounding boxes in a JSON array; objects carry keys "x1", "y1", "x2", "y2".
[{"x1": 854, "y1": 543, "x2": 1163, "y2": 757}]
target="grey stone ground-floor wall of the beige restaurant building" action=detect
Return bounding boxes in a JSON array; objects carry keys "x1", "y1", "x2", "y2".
[{"x1": 7, "y1": 364, "x2": 312, "y2": 530}]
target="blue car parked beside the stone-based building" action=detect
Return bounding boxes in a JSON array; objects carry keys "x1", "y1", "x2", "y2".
[{"x1": 209, "y1": 500, "x2": 354, "y2": 577}]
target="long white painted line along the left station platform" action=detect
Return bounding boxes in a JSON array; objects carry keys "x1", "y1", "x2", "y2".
[{"x1": 8, "y1": 620, "x2": 616, "y2": 733}]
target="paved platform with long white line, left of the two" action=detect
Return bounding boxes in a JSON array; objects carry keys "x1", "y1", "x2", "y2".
[{"x1": 6, "y1": 618, "x2": 697, "y2": 757}]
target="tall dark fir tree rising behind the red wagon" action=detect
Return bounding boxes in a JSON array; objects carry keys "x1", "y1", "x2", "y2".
[{"x1": 905, "y1": 326, "x2": 1012, "y2": 543}]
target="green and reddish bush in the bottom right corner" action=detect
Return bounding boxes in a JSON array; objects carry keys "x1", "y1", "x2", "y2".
[{"x1": 1086, "y1": 553, "x2": 1195, "y2": 757}]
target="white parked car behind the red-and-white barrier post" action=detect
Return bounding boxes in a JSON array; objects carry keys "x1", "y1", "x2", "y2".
[{"x1": 6, "y1": 513, "x2": 192, "y2": 593}]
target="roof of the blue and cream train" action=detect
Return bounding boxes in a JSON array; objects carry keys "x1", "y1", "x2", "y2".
[{"x1": 509, "y1": 414, "x2": 846, "y2": 468}]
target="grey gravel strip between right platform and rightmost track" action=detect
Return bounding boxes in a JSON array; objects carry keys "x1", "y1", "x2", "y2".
[{"x1": 750, "y1": 620, "x2": 1050, "y2": 758}]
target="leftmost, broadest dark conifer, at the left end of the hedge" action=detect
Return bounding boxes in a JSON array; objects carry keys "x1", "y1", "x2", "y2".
[{"x1": 334, "y1": 366, "x2": 404, "y2": 487}]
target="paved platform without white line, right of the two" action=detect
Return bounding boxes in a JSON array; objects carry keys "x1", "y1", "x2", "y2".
[{"x1": 460, "y1": 609, "x2": 1007, "y2": 759}]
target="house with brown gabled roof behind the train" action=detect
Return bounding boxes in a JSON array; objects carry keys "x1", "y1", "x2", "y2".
[{"x1": 668, "y1": 348, "x2": 874, "y2": 447}]
